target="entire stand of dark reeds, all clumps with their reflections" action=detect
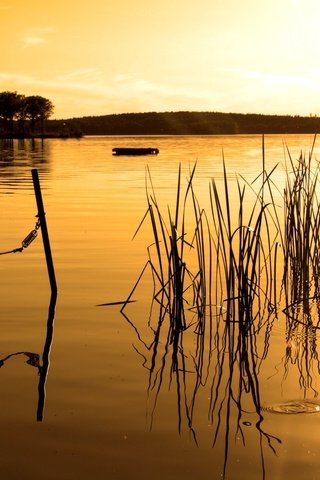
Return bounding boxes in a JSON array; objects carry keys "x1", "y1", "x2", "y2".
[{"x1": 122, "y1": 142, "x2": 320, "y2": 474}]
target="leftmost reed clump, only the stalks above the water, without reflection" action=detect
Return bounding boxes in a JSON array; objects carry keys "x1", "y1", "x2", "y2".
[{"x1": 127, "y1": 165, "x2": 211, "y2": 331}]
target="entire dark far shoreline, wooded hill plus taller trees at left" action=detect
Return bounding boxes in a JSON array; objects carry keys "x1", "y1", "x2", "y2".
[{"x1": 0, "y1": 91, "x2": 320, "y2": 138}]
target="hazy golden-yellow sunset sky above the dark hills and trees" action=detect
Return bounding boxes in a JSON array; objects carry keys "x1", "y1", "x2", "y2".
[{"x1": 0, "y1": 0, "x2": 320, "y2": 118}]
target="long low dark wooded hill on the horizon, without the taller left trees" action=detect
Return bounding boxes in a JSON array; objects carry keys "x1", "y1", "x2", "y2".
[{"x1": 47, "y1": 111, "x2": 320, "y2": 135}]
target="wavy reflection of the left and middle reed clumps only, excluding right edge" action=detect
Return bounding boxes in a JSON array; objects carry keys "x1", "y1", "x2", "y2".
[{"x1": 122, "y1": 292, "x2": 281, "y2": 478}]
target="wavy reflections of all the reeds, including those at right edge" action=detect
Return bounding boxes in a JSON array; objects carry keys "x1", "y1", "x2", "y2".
[{"x1": 122, "y1": 278, "x2": 320, "y2": 479}]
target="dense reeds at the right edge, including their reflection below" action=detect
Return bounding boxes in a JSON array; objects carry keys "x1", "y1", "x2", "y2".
[{"x1": 283, "y1": 136, "x2": 320, "y2": 398}]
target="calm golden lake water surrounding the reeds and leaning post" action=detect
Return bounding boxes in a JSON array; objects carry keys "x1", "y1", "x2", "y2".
[{"x1": 0, "y1": 135, "x2": 320, "y2": 480}]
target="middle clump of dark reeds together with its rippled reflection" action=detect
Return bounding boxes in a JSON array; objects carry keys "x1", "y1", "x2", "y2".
[{"x1": 209, "y1": 150, "x2": 279, "y2": 478}]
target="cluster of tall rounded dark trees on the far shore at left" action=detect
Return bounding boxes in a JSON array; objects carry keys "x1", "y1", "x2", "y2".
[{"x1": 0, "y1": 91, "x2": 54, "y2": 138}]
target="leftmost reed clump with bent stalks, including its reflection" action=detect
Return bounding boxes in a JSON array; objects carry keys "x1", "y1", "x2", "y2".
[{"x1": 121, "y1": 165, "x2": 211, "y2": 441}]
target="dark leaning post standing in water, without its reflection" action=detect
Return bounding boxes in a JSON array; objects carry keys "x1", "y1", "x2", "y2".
[{"x1": 31, "y1": 168, "x2": 57, "y2": 292}]
